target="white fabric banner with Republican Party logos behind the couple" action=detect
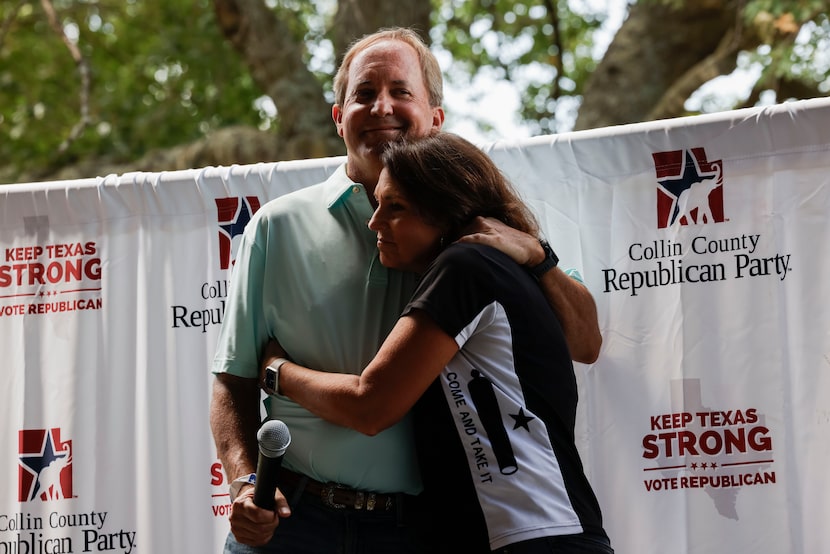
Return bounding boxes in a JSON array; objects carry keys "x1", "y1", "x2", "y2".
[{"x1": 0, "y1": 99, "x2": 830, "y2": 554}]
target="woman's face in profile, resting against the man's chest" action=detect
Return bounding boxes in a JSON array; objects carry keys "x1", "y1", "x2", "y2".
[{"x1": 369, "y1": 168, "x2": 442, "y2": 273}]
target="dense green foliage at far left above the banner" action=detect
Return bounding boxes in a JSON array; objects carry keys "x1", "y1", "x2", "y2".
[{"x1": 0, "y1": 0, "x2": 261, "y2": 177}]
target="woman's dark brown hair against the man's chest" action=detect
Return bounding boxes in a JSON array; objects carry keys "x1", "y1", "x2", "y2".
[{"x1": 381, "y1": 132, "x2": 539, "y2": 241}]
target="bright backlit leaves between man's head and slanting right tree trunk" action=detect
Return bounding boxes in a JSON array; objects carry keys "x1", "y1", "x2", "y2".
[{"x1": 432, "y1": 0, "x2": 606, "y2": 134}]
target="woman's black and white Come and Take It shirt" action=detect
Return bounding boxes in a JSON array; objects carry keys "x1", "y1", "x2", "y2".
[{"x1": 404, "y1": 244, "x2": 605, "y2": 552}]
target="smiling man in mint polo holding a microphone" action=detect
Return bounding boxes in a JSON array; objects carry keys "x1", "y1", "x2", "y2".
[{"x1": 210, "y1": 29, "x2": 601, "y2": 552}]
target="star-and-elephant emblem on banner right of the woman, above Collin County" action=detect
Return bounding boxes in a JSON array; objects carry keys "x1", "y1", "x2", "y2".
[{"x1": 651, "y1": 147, "x2": 724, "y2": 229}]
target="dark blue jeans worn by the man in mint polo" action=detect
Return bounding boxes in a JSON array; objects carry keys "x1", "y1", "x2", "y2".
[{"x1": 224, "y1": 494, "x2": 431, "y2": 554}]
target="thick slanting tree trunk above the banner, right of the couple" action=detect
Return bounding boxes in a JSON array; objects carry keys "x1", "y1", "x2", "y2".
[{"x1": 574, "y1": 0, "x2": 752, "y2": 130}]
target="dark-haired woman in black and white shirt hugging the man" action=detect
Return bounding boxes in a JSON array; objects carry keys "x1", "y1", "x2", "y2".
[{"x1": 269, "y1": 133, "x2": 613, "y2": 553}]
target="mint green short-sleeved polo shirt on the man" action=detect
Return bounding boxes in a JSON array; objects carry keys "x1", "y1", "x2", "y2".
[{"x1": 213, "y1": 165, "x2": 421, "y2": 494}]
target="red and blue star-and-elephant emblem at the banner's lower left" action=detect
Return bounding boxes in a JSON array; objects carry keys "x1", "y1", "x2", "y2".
[{"x1": 17, "y1": 427, "x2": 73, "y2": 502}]
